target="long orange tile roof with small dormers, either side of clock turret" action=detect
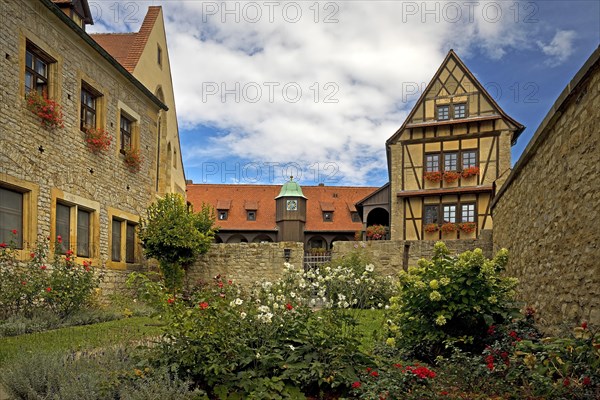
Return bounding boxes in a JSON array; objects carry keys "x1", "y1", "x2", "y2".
[{"x1": 187, "y1": 184, "x2": 377, "y2": 232}]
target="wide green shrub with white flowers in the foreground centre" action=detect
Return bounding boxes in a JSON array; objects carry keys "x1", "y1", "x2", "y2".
[{"x1": 150, "y1": 264, "x2": 373, "y2": 399}]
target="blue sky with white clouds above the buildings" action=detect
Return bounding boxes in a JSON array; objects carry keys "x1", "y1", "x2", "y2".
[{"x1": 89, "y1": 0, "x2": 600, "y2": 186}]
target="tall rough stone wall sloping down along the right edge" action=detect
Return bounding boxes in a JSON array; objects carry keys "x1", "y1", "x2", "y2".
[{"x1": 493, "y1": 50, "x2": 600, "y2": 333}]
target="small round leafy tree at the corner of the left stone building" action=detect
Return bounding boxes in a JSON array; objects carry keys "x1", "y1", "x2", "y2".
[{"x1": 139, "y1": 194, "x2": 215, "y2": 290}]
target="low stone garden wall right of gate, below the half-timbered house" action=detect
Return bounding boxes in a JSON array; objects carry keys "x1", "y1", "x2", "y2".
[{"x1": 333, "y1": 230, "x2": 492, "y2": 276}]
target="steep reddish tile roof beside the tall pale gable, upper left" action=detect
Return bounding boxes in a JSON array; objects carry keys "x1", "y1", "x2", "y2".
[{"x1": 90, "y1": 6, "x2": 161, "y2": 72}]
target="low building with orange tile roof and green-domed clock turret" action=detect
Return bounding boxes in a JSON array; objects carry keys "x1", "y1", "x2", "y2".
[{"x1": 187, "y1": 180, "x2": 377, "y2": 249}]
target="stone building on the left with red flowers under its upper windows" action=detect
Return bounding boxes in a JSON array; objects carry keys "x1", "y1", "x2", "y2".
[{"x1": 0, "y1": 0, "x2": 184, "y2": 269}]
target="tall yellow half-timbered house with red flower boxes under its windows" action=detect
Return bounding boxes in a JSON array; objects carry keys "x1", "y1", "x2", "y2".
[{"x1": 382, "y1": 50, "x2": 524, "y2": 240}]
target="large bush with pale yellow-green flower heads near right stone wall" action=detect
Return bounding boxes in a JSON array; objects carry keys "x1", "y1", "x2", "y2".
[{"x1": 388, "y1": 242, "x2": 518, "y2": 359}]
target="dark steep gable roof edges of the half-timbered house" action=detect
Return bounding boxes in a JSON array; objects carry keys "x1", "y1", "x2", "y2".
[{"x1": 386, "y1": 49, "x2": 525, "y2": 146}]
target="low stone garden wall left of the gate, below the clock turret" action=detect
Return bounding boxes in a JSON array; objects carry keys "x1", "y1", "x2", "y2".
[{"x1": 187, "y1": 242, "x2": 304, "y2": 287}]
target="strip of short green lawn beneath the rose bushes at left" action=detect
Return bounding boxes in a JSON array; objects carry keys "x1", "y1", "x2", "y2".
[{"x1": 0, "y1": 317, "x2": 162, "y2": 367}]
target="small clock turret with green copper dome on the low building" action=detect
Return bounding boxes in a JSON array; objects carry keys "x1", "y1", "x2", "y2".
[{"x1": 275, "y1": 177, "x2": 307, "y2": 242}]
